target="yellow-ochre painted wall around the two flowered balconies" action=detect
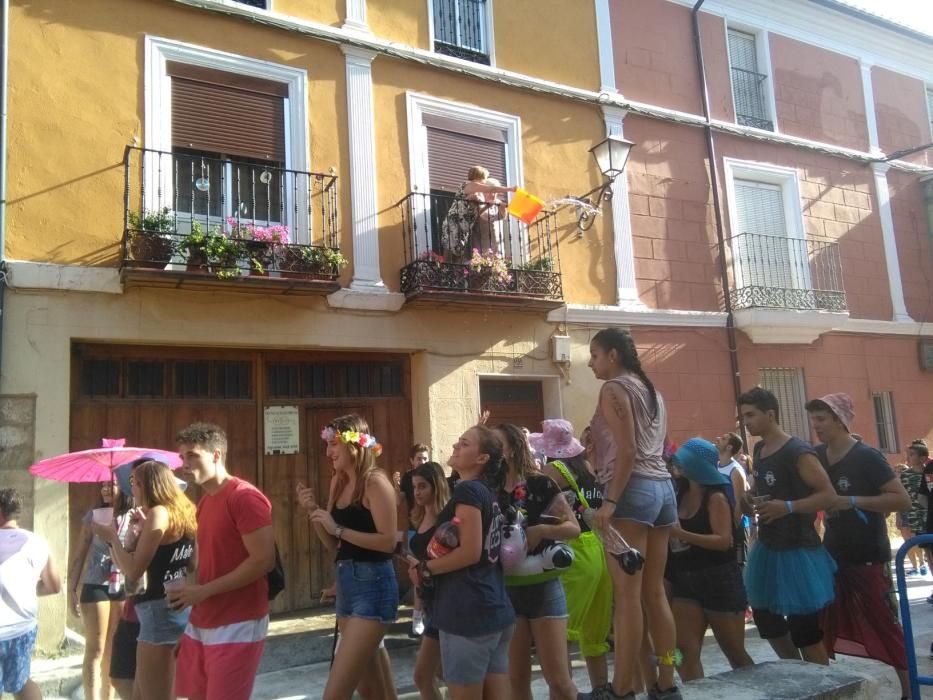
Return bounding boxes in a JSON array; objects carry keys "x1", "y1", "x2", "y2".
[{"x1": 7, "y1": 0, "x2": 615, "y2": 303}]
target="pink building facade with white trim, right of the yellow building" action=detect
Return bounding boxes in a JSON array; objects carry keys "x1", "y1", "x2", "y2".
[{"x1": 568, "y1": 0, "x2": 933, "y2": 462}]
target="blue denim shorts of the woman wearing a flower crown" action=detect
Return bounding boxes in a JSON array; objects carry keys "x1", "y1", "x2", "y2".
[{"x1": 336, "y1": 559, "x2": 398, "y2": 624}]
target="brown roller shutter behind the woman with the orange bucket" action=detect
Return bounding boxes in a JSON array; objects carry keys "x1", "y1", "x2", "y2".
[{"x1": 427, "y1": 126, "x2": 510, "y2": 192}]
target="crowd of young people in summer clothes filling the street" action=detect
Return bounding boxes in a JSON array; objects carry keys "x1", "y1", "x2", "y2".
[{"x1": 0, "y1": 328, "x2": 933, "y2": 700}]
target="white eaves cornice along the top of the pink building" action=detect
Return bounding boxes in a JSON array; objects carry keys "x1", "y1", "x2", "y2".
[{"x1": 668, "y1": 0, "x2": 933, "y2": 82}]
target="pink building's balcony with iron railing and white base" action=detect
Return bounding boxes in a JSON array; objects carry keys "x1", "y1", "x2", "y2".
[{"x1": 728, "y1": 233, "x2": 848, "y2": 343}]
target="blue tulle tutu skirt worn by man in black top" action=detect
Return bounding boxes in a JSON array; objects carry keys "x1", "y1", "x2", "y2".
[{"x1": 745, "y1": 542, "x2": 836, "y2": 615}]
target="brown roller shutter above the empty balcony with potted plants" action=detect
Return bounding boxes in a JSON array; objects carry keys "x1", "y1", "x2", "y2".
[{"x1": 168, "y1": 63, "x2": 287, "y2": 162}]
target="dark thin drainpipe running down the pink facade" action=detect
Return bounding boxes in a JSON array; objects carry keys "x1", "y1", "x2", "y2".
[{"x1": 690, "y1": 0, "x2": 748, "y2": 434}]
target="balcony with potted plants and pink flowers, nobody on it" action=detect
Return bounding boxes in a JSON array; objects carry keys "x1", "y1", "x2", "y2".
[{"x1": 120, "y1": 147, "x2": 346, "y2": 294}]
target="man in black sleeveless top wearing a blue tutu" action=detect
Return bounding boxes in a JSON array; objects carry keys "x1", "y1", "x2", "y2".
[{"x1": 739, "y1": 387, "x2": 836, "y2": 664}]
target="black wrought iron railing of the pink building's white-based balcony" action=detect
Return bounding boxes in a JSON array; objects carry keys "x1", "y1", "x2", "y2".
[{"x1": 728, "y1": 233, "x2": 848, "y2": 311}]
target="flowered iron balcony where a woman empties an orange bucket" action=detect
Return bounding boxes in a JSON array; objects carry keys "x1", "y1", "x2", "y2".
[{"x1": 397, "y1": 192, "x2": 563, "y2": 310}]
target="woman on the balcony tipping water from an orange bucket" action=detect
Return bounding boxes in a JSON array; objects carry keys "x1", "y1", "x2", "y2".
[{"x1": 441, "y1": 165, "x2": 515, "y2": 262}]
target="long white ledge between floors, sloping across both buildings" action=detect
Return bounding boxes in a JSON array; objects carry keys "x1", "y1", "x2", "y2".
[{"x1": 172, "y1": 0, "x2": 933, "y2": 174}]
